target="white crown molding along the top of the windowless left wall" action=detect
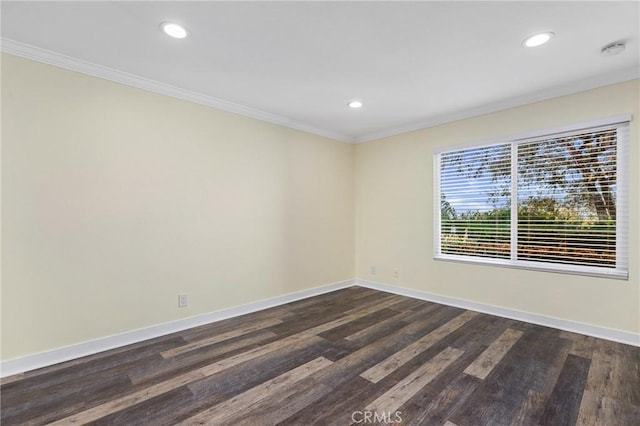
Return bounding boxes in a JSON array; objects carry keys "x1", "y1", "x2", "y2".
[{"x1": 0, "y1": 38, "x2": 354, "y2": 143}]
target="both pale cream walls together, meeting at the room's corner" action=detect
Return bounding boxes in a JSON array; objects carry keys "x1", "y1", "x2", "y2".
[{"x1": 2, "y1": 50, "x2": 640, "y2": 360}]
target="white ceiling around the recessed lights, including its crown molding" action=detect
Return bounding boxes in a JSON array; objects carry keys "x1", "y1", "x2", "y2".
[{"x1": 1, "y1": 1, "x2": 640, "y2": 142}]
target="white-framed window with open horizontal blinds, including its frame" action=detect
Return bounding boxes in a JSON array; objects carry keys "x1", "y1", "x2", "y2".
[{"x1": 434, "y1": 116, "x2": 630, "y2": 279}]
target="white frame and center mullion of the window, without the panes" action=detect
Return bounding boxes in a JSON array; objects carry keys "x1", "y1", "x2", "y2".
[{"x1": 433, "y1": 114, "x2": 632, "y2": 280}]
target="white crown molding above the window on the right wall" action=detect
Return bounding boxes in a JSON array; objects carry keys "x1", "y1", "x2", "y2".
[{"x1": 353, "y1": 67, "x2": 640, "y2": 144}]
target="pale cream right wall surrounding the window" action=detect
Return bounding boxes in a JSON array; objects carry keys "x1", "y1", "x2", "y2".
[{"x1": 356, "y1": 80, "x2": 640, "y2": 333}]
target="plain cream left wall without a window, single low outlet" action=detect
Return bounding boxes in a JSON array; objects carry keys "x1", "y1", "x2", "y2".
[{"x1": 2, "y1": 55, "x2": 355, "y2": 360}]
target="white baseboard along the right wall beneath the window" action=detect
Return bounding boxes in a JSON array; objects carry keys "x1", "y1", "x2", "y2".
[{"x1": 355, "y1": 280, "x2": 640, "y2": 346}]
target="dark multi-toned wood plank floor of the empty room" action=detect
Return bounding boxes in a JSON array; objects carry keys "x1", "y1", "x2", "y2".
[{"x1": 0, "y1": 287, "x2": 640, "y2": 426}]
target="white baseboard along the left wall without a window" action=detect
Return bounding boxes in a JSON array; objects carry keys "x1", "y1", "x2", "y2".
[{"x1": 0, "y1": 280, "x2": 355, "y2": 377}]
